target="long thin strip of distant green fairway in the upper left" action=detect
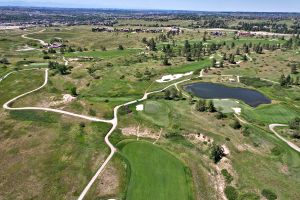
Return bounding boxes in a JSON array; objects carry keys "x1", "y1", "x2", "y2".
[{"x1": 65, "y1": 49, "x2": 141, "y2": 59}]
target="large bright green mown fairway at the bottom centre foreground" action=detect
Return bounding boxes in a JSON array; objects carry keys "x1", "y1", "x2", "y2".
[{"x1": 122, "y1": 141, "x2": 193, "y2": 200}]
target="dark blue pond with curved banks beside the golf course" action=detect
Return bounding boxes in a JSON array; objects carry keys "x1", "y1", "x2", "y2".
[{"x1": 184, "y1": 83, "x2": 271, "y2": 107}]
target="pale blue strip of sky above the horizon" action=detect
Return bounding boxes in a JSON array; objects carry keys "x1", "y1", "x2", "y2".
[{"x1": 0, "y1": 0, "x2": 300, "y2": 12}]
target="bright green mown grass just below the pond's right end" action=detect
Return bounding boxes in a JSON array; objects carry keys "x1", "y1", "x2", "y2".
[{"x1": 242, "y1": 103, "x2": 300, "y2": 124}]
